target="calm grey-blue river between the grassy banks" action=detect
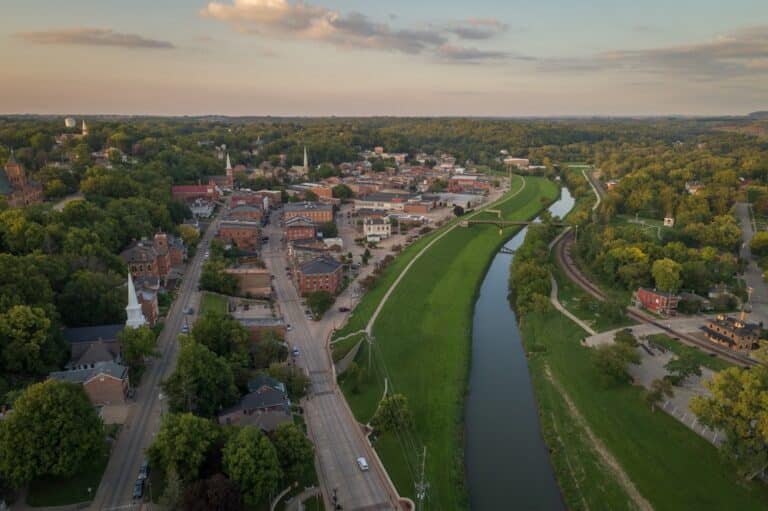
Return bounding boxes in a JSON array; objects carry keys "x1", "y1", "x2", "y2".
[{"x1": 465, "y1": 188, "x2": 575, "y2": 511}]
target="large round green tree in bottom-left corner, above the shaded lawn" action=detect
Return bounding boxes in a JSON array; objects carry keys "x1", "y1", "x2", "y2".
[{"x1": 0, "y1": 380, "x2": 105, "y2": 487}]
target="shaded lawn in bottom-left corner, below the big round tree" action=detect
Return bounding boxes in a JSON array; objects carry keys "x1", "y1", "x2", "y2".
[{"x1": 27, "y1": 447, "x2": 109, "y2": 507}]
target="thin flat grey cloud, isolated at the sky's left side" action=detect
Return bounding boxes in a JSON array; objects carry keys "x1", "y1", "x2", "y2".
[{"x1": 16, "y1": 28, "x2": 174, "y2": 49}]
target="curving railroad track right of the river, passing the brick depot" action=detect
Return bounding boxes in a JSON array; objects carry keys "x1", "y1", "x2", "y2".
[{"x1": 555, "y1": 231, "x2": 759, "y2": 367}]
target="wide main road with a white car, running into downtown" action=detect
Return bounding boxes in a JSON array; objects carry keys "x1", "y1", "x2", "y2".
[{"x1": 262, "y1": 214, "x2": 398, "y2": 510}]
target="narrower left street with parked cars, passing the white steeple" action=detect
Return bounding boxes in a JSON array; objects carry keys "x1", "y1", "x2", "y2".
[{"x1": 90, "y1": 208, "x2": 223, "y2": 510}]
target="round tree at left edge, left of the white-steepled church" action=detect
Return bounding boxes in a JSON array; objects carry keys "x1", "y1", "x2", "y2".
[{"x1": 0, "y1": 305, "x2": 66, "y2": 376}]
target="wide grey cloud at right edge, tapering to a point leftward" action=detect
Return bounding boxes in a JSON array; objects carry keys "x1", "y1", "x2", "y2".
[{"x1": 542, "y1": 25, "x2": 768, "y2": 80}]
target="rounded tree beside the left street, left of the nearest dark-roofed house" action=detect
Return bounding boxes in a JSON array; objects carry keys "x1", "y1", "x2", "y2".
[{"x1": 148, "y1": 413, "x2": 221, "y2": 481}]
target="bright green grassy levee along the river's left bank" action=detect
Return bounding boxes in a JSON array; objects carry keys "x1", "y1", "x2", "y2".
[{"x1": 342, "y1": 178, "x2": 558, "y2": 509}]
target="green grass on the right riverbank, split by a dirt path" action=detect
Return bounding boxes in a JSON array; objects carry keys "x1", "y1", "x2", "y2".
[{"x1": 521, "y1": 311, "x2": 768, "y2": 510}]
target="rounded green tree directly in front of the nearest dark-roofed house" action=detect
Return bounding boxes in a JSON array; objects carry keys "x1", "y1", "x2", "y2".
[{"x1": 224, "y1": 426, "x2": 283, "y2": 507}]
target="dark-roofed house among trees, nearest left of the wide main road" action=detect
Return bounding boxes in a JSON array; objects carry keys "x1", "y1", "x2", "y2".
[{"x1": 219, "y1": 384, "x2": 293, "y2": 432}]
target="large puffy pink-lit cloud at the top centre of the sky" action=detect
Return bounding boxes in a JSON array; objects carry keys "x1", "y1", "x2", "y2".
[{"x1": 200, "y1": 0, "x2": 506, "y2": 61}]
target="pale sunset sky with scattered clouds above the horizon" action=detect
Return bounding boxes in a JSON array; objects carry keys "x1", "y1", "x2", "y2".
[{"x1": 0, "y1": 0, "x2": 768, "y2": 117}]
